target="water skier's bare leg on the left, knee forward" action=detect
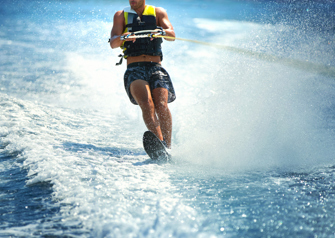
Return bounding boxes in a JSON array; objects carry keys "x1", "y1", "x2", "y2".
[{"x1": 130, "y1": 79, "x2": 163, "y2": 140}]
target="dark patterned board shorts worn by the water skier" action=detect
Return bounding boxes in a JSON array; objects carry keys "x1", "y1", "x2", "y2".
[{"x1": 124, "y1": 62, "x2": 176, "y2": 105}]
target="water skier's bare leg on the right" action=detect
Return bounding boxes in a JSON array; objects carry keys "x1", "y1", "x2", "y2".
[{"x1": 152, "y1": 88, "x2": 172, "y2": 148}]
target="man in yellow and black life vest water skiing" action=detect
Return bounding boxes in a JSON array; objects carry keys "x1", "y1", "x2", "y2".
[{"x1": 110, "y1": 0, "x2": 176, "y2": 148}]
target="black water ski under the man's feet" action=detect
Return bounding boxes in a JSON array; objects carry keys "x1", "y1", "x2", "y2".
[{"x1": 143, "y1": 131, "x2": 170, "y2": 160}]
